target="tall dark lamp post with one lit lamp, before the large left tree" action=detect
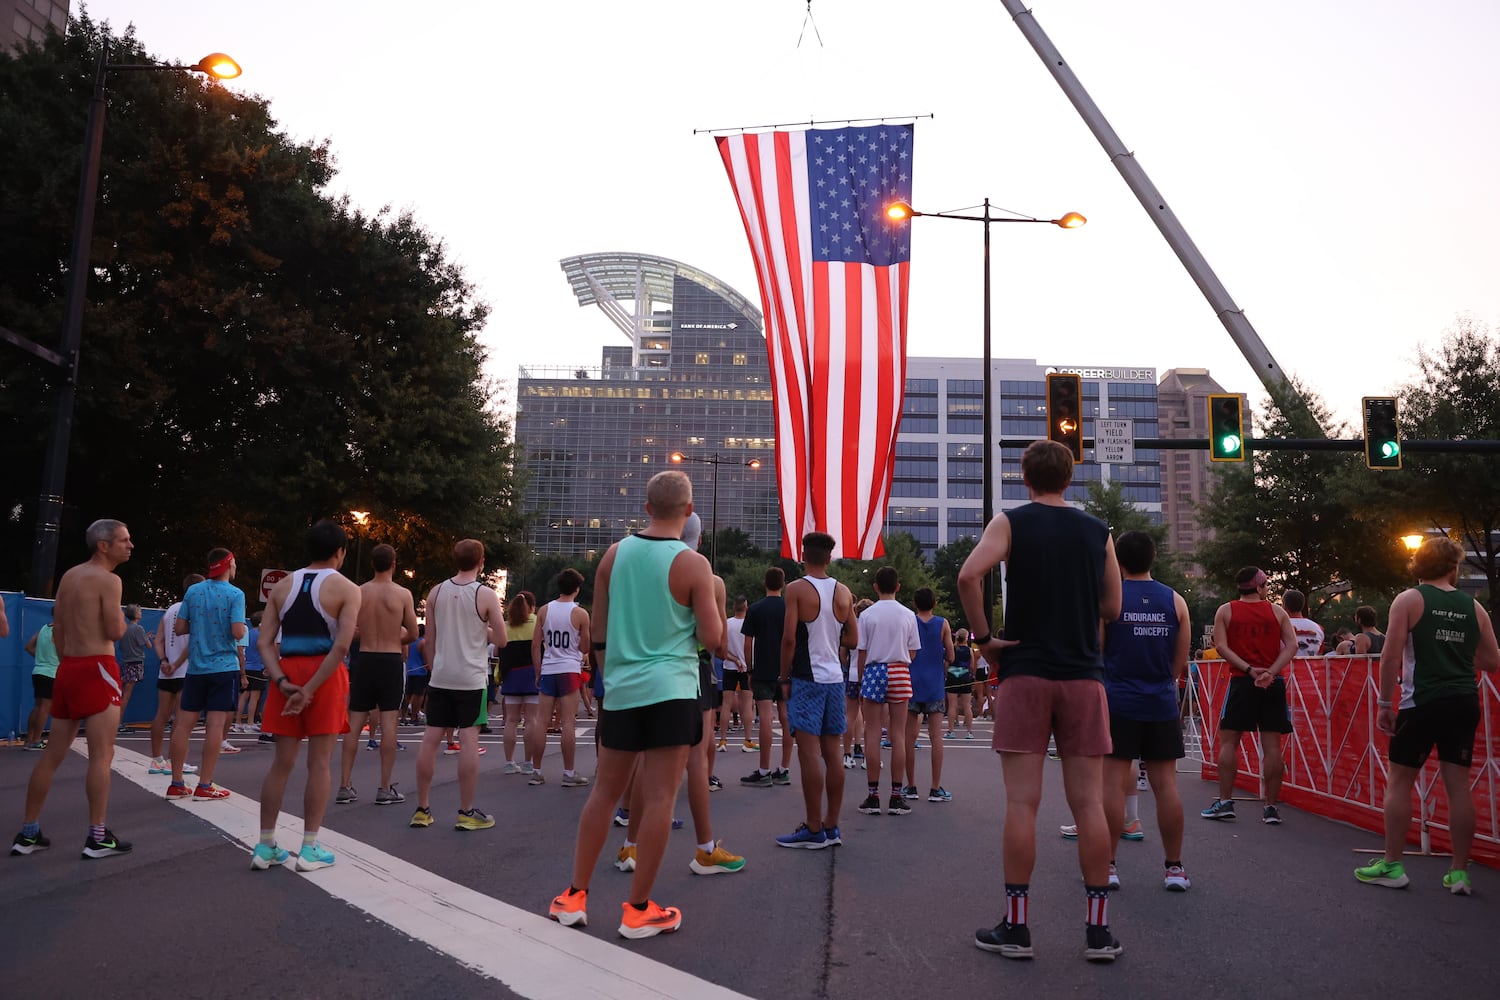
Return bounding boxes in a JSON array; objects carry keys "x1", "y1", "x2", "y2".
[{"x1": 20, "y1": 39, "x2": 240, "y2": 598}]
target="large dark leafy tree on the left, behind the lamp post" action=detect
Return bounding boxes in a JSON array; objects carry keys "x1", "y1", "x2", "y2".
[{"x1": 0, "y1": 13, "x2": 521, "y2": 597}]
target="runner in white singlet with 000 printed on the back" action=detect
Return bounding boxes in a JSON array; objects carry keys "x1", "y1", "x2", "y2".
[{"x1": 527, "y1": 567, "x2": 590, "y2": 789}]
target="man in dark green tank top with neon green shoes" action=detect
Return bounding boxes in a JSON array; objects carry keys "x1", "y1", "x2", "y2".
[{"x1": 1355, "y1": 538, "x2": 1500, "y2": 895}]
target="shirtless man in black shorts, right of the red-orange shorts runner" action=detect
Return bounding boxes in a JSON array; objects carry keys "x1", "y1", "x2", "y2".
[{"x1": 338, "y1": 544, "x2": 417, "y2": 805}]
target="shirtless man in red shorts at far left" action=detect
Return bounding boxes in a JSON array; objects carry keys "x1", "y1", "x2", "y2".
[{"x1": 11, "y1": 519, "x2": 135, "y2": 858}]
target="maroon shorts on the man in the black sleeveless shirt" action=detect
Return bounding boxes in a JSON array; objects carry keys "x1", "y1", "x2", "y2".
[{"x1": 990, "y1": 673, "x2": 1113, "y2": 757}]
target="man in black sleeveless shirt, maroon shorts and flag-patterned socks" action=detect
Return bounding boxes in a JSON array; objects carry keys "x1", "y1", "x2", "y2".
[{"x1": 959, "y1": 441, "x2": 1122, "y2": 961}]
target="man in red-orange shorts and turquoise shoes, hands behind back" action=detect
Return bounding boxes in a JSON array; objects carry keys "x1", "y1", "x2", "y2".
[{"x1": 251, "y1": 520, "x2": 360, "y2": 871}]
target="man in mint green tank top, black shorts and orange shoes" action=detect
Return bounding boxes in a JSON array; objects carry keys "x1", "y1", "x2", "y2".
[{"x1": 548, "y1": 471, "x2": 725, "y2": 939}]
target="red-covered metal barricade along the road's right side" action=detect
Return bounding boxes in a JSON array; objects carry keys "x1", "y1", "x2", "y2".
[{"x1": 1193, "y1": 657, "x2": 1500, "y2": 867}]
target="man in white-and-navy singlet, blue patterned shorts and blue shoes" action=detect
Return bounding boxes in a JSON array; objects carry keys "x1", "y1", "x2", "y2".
[{"x1": 776, "y1": 531, "x2": 860, "y2": 850}]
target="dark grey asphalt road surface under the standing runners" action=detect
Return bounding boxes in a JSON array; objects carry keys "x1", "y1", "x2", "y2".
[{"x1": 0, "y1": 720, "x2": 1500, "y2": 1000}]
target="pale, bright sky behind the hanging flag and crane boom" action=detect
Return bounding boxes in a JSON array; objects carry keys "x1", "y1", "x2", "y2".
[{"x1": 74, "y1": 0, "x2": 1500, "y2": 433}]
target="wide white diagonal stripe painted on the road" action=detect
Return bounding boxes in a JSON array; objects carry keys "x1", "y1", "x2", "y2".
[{"x1": 93, "y1": 741, "x2": 749, "y2": 1000}]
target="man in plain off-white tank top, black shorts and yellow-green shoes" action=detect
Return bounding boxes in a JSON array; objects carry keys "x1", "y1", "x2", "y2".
[{"x1": 411, "y1": 538, "x2": 506, "y2": 831}]
